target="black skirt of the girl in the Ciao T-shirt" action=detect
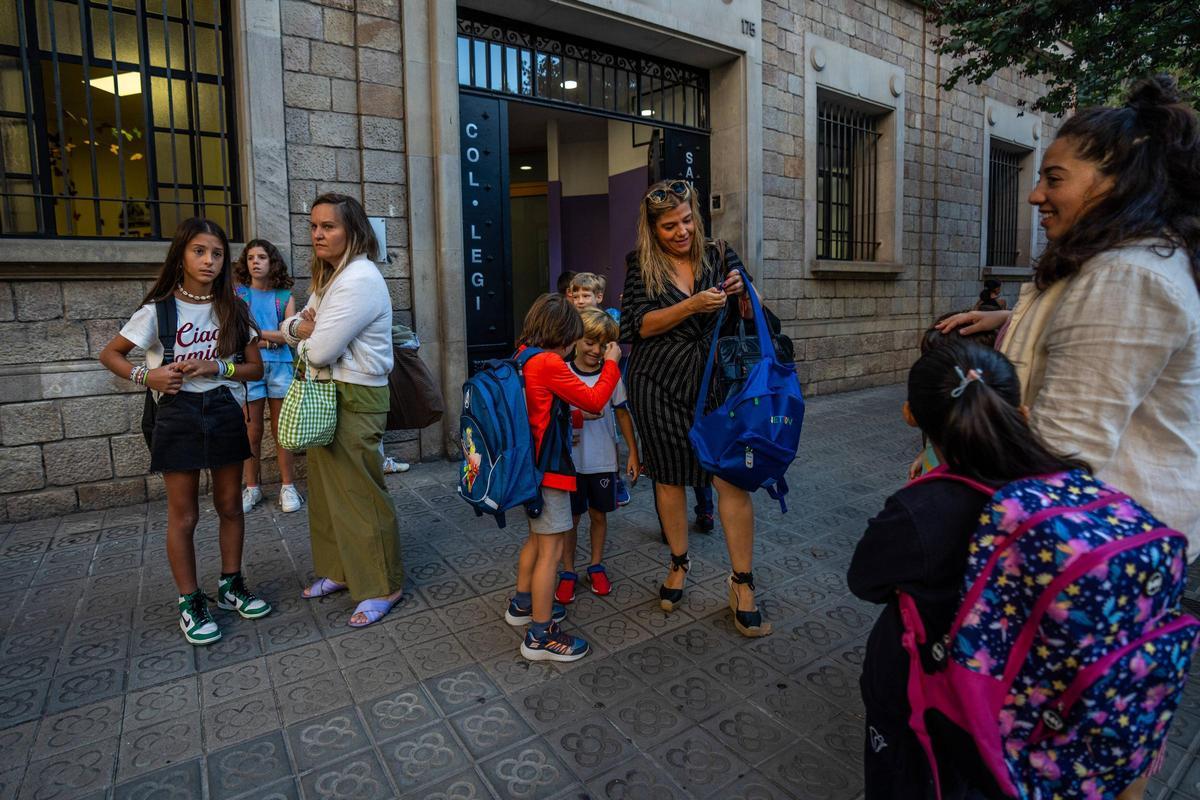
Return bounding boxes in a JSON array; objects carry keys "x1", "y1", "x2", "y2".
[{"x1": 149, "y1": 386, "x2": 250, "y2": 473}]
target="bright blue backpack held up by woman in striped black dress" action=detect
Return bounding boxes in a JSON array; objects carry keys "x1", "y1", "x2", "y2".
[{"x1": 688, "y1": 269, "x2": 804, "y2": 512}]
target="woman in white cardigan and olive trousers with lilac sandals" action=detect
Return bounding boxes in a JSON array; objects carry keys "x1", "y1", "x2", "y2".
[{"x1": 281, "y1": 194, "x2": 404, "y2": 627}]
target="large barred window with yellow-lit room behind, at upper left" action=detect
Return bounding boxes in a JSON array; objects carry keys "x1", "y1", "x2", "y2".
[{"x1": 0, "y1": 0, "x2": 242, "y2": 240}]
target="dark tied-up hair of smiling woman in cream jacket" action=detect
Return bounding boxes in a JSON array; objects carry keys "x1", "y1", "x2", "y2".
[{"x1": 1037, "y1": 74, "x2": 1200, "y2": 289}]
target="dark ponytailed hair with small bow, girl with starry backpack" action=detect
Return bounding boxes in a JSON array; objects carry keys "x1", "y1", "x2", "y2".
[{"x1": 908, "y1": 339, "x2": 1090, "y2": 486}]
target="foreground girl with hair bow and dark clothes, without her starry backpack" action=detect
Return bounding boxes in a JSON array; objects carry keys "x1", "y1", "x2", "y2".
[{"x1": 847, "y1": 337, "x2": 1088, "y2": 800}]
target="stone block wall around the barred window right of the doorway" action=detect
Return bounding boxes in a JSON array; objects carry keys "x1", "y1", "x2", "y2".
[{"x1": 760, "y1": 0, "x2": 1055, "y2": 393}]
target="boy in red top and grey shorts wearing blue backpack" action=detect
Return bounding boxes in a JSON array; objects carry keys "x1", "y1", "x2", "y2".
[{"x1": 460, "y1": 294, "x2": 620, "y2": 661}]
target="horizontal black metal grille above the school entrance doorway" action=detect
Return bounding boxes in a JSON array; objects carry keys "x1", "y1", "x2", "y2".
[{"x1": 458, "y1": 10, "x2": 708, "y2": 131}]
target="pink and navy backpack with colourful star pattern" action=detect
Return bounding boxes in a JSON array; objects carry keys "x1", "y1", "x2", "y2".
[{"x1": 900, "y1": 467, "x2": 1200, "y2": 800}]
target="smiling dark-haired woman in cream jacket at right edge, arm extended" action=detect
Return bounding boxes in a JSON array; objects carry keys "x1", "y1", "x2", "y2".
[{"x1": 941, "y1": 76, "x2": 1200, "y2": 560}]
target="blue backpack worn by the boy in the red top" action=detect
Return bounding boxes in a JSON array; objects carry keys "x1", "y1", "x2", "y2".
[{"x1": 458, "y1": 348, "x2": 542, "y2": 528}]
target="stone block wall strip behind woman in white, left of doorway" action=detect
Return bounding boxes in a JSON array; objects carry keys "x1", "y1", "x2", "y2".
[{"x1": 280, "y1": 0, "x2": 420, "y2": 461}]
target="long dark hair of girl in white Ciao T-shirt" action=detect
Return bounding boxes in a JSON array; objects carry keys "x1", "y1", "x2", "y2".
[{"x1": 142, "y1": 217, "x2": 253, "y2": 356}]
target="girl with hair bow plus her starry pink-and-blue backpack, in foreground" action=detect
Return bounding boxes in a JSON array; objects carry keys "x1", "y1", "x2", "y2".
[{"x1": 847, "y1": 341, "x2": 1200, "y2": 800}]
